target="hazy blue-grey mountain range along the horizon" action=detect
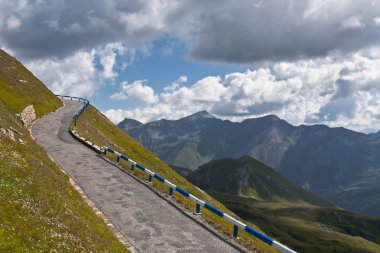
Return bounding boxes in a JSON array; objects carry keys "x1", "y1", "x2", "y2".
[{"x1": 118, "y1": 111, "x2": 380, "y2": 216}]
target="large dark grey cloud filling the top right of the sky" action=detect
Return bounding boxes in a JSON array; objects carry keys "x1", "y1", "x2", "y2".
[{"x1": 186, "y1": 0, "x2": 380, "y2": 63}]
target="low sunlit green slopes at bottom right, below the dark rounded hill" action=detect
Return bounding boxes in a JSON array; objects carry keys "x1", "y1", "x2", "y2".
[{"x1": 212, "y1": 196, "x2": 380, "y2": 252}]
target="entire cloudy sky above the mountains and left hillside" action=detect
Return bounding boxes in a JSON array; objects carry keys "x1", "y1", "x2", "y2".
[{"x1": 0, "y1": 0, "x2": 380, "y2": 133}]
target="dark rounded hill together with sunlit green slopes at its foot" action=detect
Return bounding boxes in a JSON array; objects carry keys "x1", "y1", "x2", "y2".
[{"x1": 188, "y1": 156, "x2": 380, "y2": 252}]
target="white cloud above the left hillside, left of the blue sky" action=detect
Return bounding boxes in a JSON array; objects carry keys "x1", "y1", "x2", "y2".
[{"x1": 27, "y1": 43, "x2": 127, "y2": 97}]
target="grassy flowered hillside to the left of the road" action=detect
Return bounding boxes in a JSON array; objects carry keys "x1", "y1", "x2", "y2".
[{"x1": 0, "y1": 51, "x2": 127, "y2": 252}]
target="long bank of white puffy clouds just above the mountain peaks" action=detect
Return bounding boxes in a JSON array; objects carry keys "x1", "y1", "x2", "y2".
[{"x1": 105, "y1": 53, "x2": 380, "y2": 131}]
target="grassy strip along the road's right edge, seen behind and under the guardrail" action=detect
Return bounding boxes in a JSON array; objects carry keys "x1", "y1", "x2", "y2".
[{"x1": 75, "y1": 106, "x2": 282, "y2": 252}]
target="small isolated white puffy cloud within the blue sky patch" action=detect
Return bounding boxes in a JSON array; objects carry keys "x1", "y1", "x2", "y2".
[{"x1": 110, "y1": 80, "x2": 158, "y2": 104}]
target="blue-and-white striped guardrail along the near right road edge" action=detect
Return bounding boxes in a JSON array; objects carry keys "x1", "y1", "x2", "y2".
[{"x1": 101, "y1": 147, "x2": 296, "y2": 253}]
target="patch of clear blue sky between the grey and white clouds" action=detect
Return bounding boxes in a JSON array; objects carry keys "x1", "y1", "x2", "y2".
[{"x1": 91, "y1": 37, "x2": 245, "y2": 111}]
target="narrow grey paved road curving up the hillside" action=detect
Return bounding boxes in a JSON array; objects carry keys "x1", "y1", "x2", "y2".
[{"x1": 32, "y1": 101, "x2": 238, "y2": 252}]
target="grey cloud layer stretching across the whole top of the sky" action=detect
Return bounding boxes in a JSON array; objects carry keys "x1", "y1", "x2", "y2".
[{"x1": 0, "y1": 0, "x2": 380, "y2": 63}]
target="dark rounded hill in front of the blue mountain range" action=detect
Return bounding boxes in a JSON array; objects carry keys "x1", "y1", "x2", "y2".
[{"x1": 187, "y1": 156, "x2": 334, "y2": 207}]
